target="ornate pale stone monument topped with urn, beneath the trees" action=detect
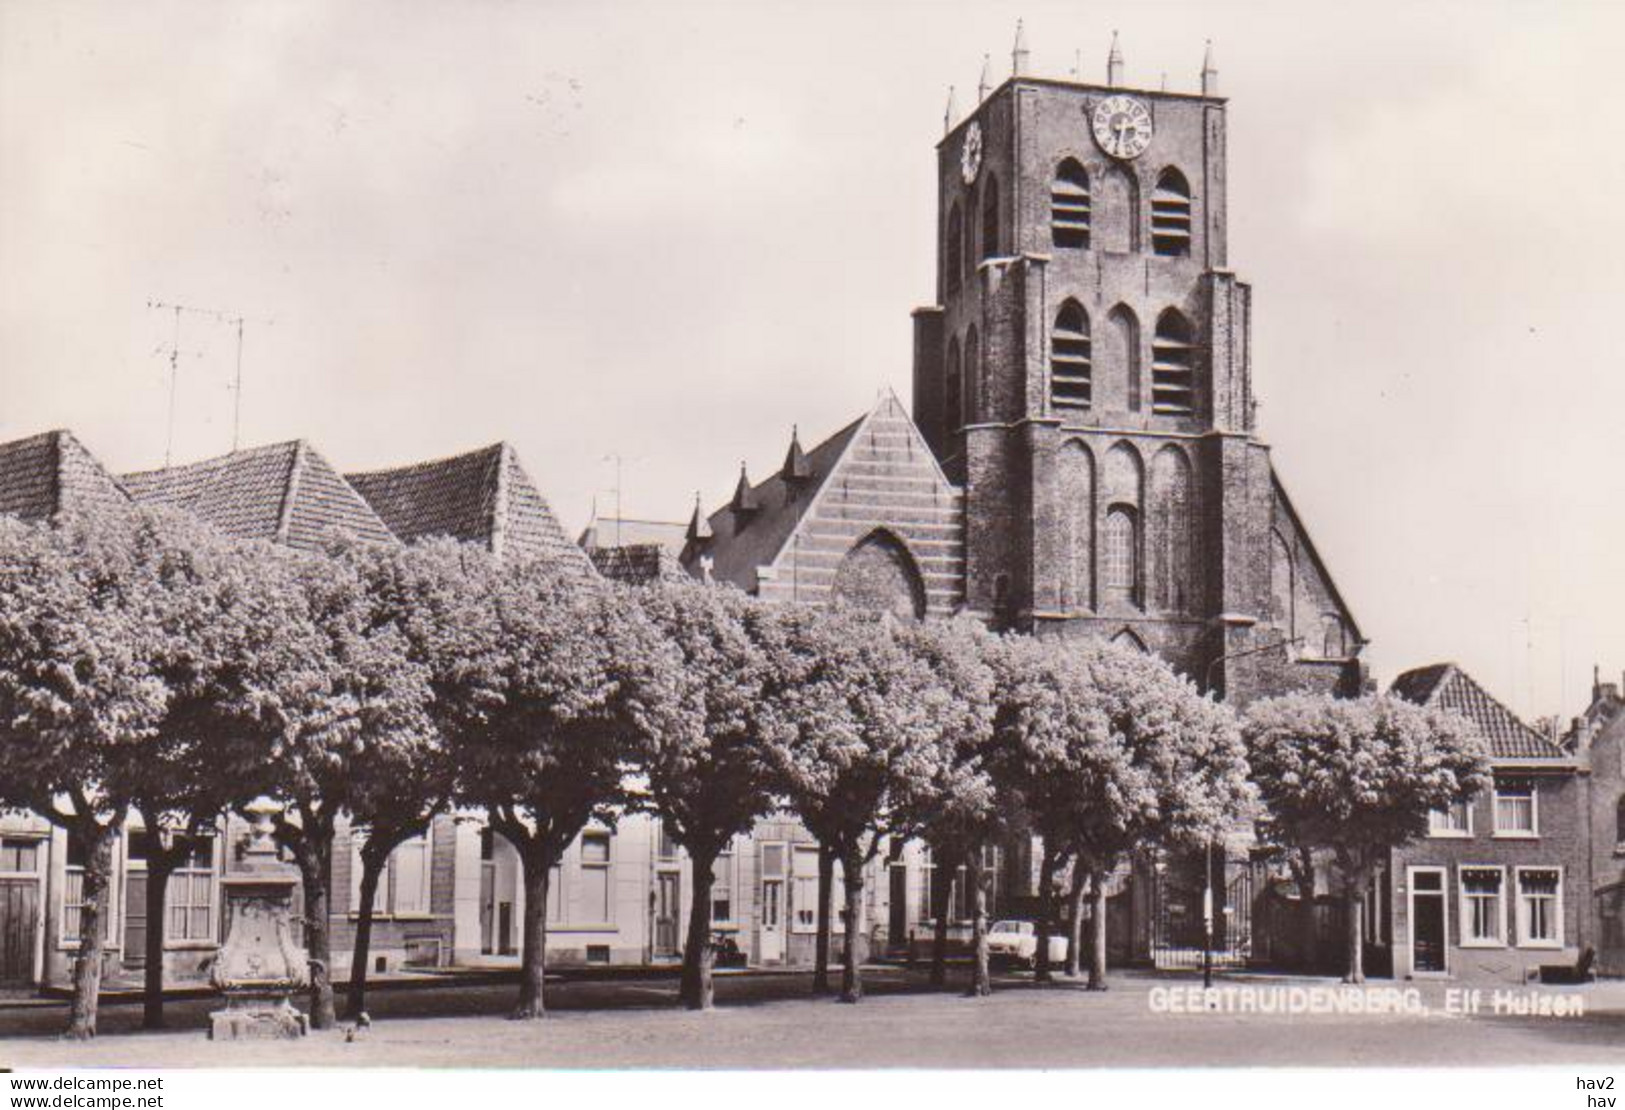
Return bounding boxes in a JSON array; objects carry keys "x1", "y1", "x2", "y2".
[{"x1": 208, "y1": 798, "x2": 310, "y2": 1040}]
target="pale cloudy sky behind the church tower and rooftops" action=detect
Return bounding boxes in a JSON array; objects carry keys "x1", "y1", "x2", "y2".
[{"x1": 0, "y1": 0, "x2": 1625, "y2": 715}]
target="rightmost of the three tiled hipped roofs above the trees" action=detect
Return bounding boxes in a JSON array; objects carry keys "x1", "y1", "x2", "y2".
[{"x1": 346, "y1": 444, "x2": 595, "y2": 577}]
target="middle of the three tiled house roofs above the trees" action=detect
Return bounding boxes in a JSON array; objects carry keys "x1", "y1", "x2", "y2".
[{"x1": 122, "y1": 440, "x2": 395, "y2": 549}]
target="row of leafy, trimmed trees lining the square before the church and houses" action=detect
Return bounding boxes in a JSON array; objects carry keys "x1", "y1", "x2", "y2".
[{"x1": 0, "y1": 509, "x2": 1485, "y2": 1037}]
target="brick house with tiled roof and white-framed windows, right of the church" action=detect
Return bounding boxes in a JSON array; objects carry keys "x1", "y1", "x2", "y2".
[{"x1": 1367, "y1": 663, "x2": 1591, "y2": 983}]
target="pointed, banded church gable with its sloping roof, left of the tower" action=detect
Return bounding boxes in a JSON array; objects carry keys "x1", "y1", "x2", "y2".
[{"x1": 683, "y1": 392, "x2": 965, "y2": 616}]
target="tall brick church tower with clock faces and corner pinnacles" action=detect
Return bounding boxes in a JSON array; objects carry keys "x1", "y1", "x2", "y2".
[{"x1": 913, "y1": 34, "x2": 1365, "y2": 700}]
